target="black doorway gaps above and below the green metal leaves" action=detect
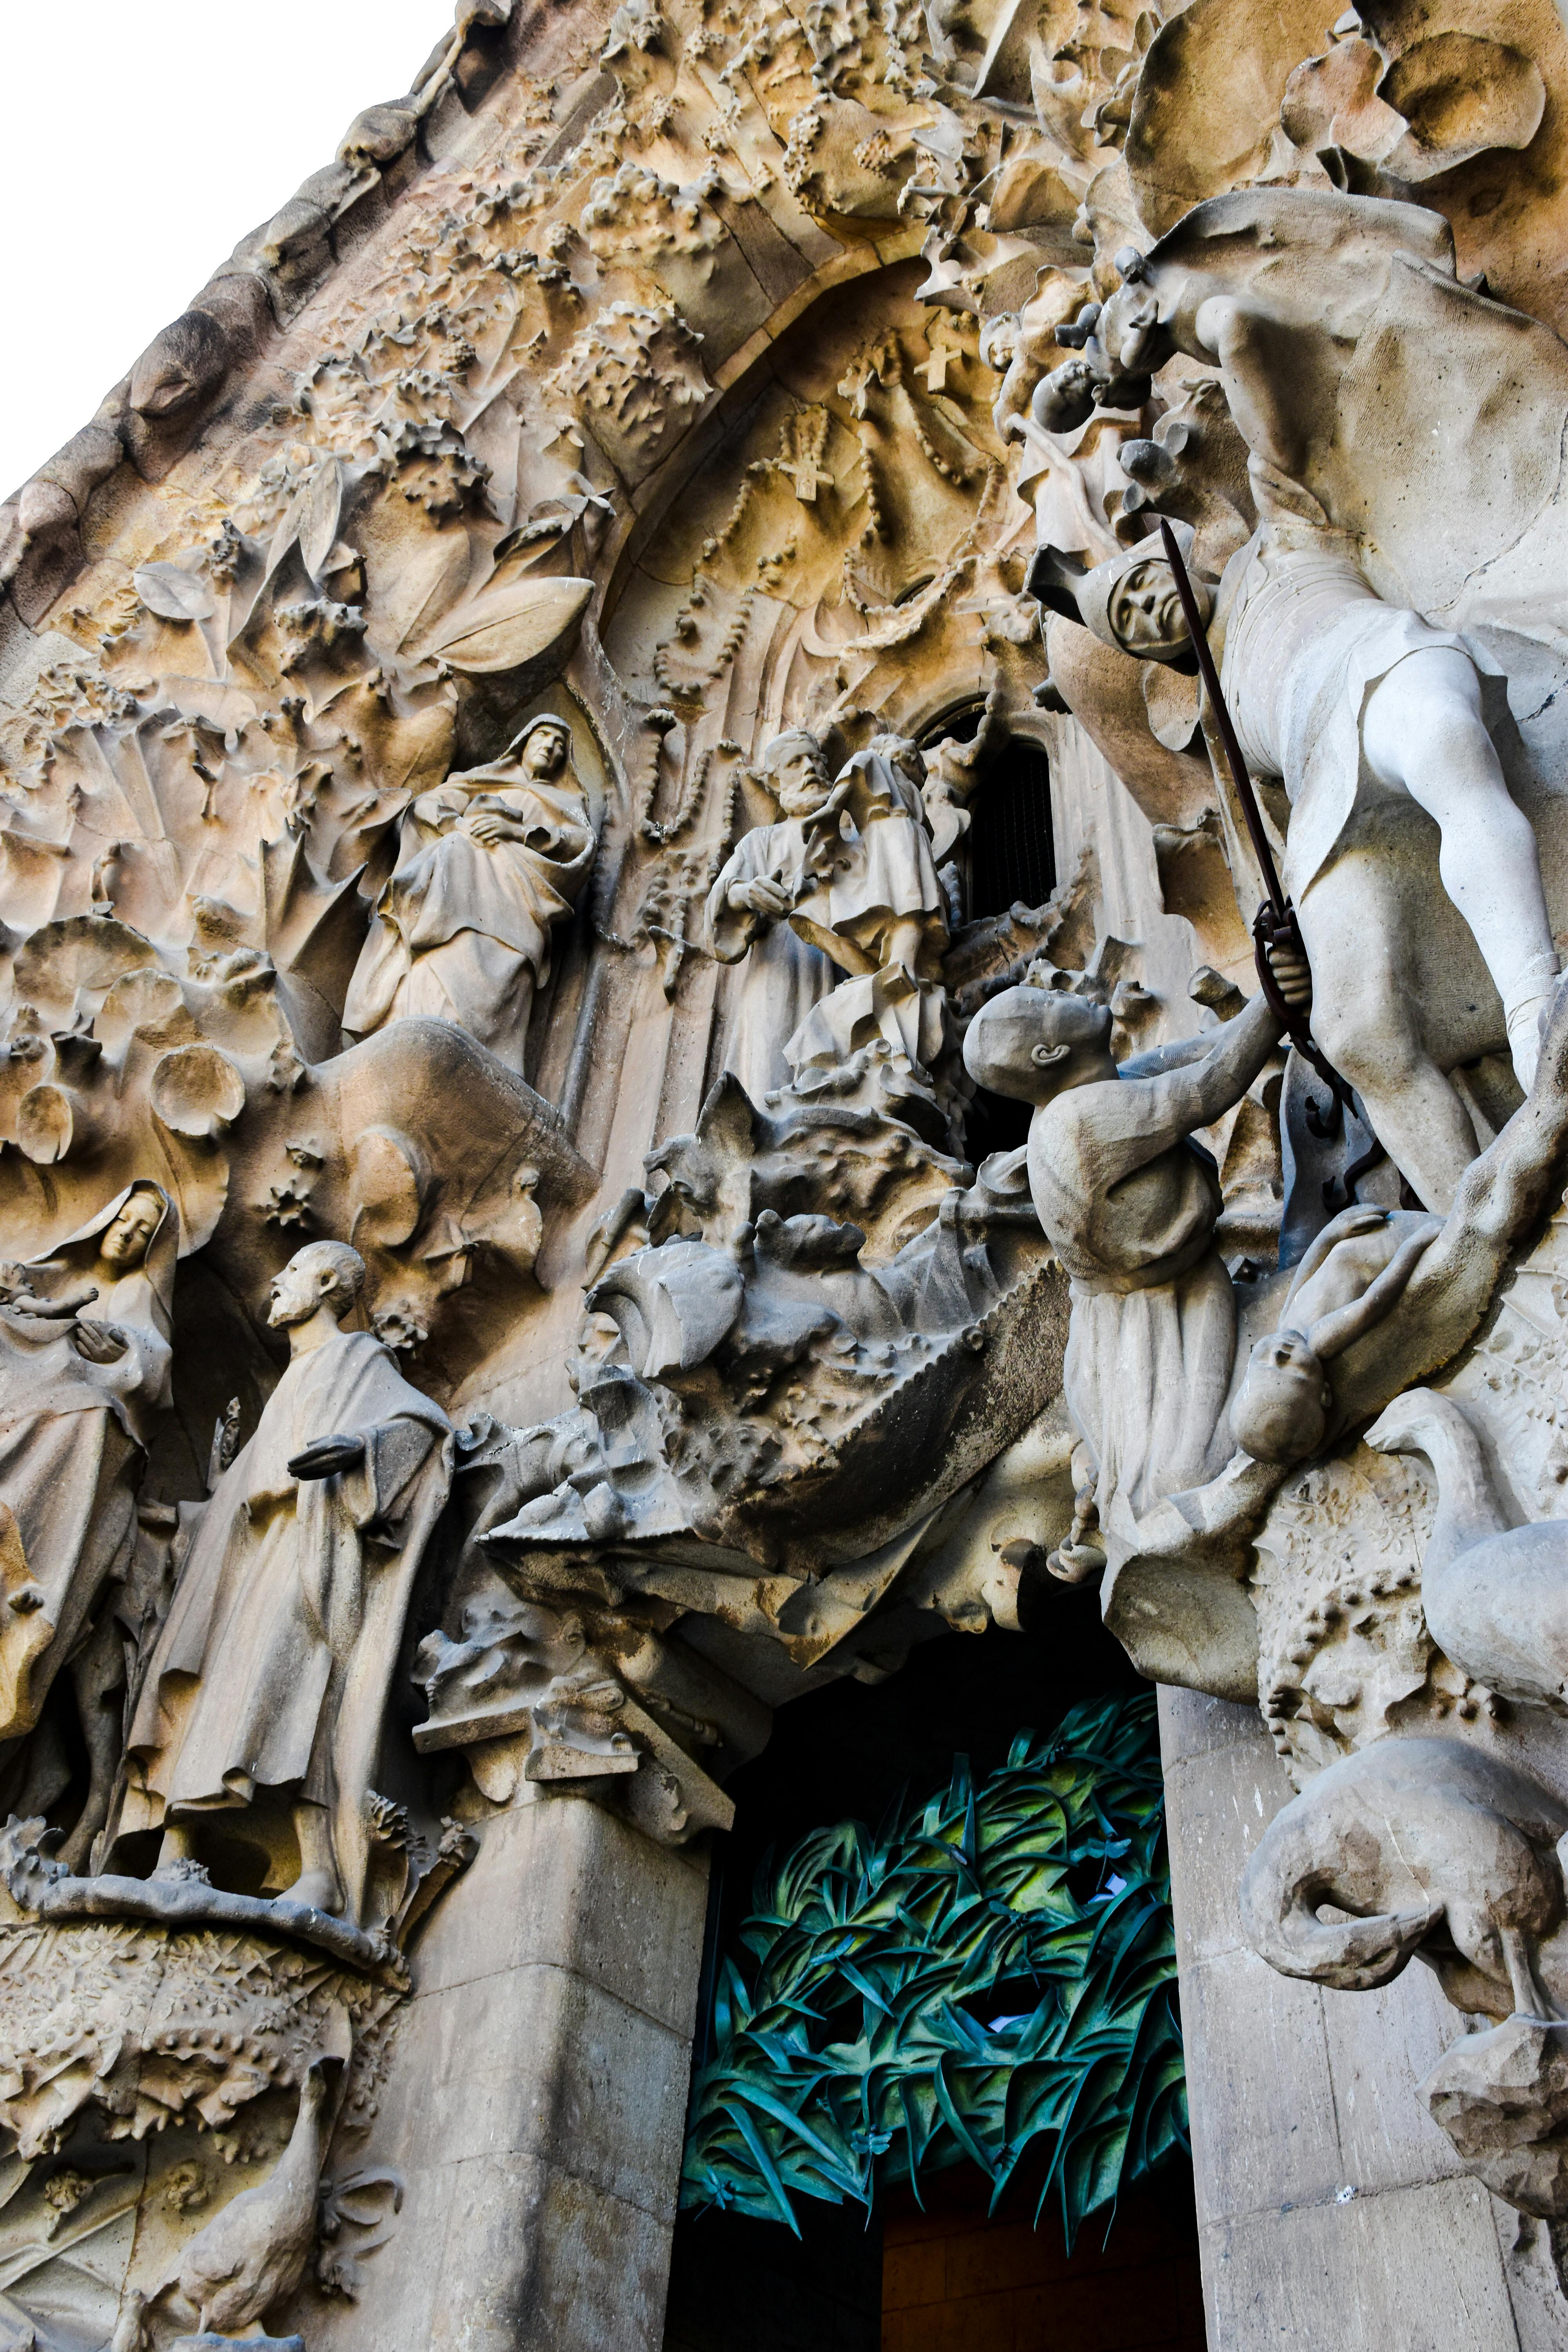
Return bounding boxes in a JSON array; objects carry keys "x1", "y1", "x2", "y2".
[{"x1": 663, "y1": 1585, "x2": 1203, "y2": 2352}]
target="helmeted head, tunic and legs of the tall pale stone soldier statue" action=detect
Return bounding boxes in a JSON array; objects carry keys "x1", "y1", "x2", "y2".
[{"x1": 1074, "y1": 534, "x2": 1559, "y2": 1209}]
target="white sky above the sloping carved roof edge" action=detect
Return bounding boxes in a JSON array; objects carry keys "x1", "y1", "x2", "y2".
[{"x1": 0, "y1": 0, "x2": 451, "y2": 496}]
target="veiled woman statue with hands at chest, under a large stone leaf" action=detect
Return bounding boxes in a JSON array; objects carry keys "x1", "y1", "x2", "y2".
[{"x1": 343, "y1": 715, "x2": 595, "y2": 1075}]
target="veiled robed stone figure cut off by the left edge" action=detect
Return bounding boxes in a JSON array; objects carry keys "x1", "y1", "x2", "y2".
[{"x1": 0, "y1": 1181, "x2": 179, "y2": 1769}]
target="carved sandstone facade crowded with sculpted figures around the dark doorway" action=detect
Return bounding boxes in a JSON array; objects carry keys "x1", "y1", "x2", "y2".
[{"x1": 12, "y1": 0, "x2": 1568, "y2": 2352}]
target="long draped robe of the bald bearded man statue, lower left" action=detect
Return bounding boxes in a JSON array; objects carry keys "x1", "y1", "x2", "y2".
[{"x1": 120, "y1": 1331, "x2": 451, "y2": 1924}]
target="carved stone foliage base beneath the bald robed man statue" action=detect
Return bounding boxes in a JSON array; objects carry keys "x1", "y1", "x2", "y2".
[{"x1": 0, "y1": 1903, "x2": 402, "y2": 2347}]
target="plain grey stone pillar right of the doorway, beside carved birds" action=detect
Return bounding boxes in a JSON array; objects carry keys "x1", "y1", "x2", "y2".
[{"x1": 1159, "y1": 1689, "x2": 1568, "y2": 2352}]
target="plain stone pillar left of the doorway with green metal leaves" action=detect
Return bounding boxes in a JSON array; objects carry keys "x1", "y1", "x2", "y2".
[{"x1": 303, "y1": 1783, "x2": 708, "y2": 2352}]
